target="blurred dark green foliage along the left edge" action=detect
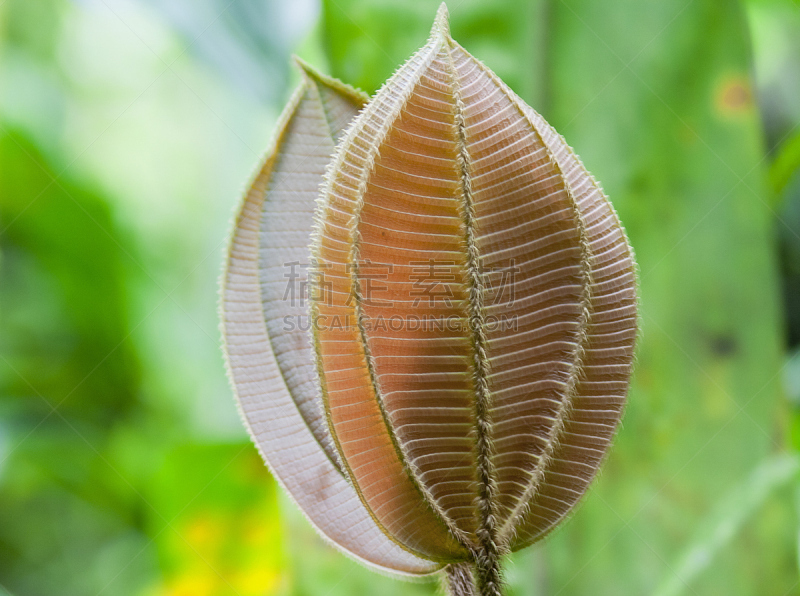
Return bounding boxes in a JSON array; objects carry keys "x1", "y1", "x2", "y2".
[{"x1": 0, "y1": 125, "x2": 154, "y2": 594}]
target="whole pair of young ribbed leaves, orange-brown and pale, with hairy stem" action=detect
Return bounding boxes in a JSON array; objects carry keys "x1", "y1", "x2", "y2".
[{"x1": 222, "y1": 5, "x2": 636, "y2": 594}]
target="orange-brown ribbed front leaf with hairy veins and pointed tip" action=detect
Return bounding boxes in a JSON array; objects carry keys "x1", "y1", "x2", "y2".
[{"x1": 312, "y1": 5, "x2": 636, "y2": 594}]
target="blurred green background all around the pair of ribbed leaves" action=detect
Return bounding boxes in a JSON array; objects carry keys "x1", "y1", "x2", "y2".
[{"x1": 0, "y1": 0, "x2": 800, "y2": 596}]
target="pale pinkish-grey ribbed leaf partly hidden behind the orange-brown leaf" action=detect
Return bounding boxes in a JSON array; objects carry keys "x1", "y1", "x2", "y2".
[{"x1": 221, "y1": 58, "x2": 439, "y2": 574}]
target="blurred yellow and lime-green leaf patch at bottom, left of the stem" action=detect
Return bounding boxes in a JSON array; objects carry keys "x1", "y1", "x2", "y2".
[{"x1": 148, "y1": 444, "x2": 287, "y2": 596}]
